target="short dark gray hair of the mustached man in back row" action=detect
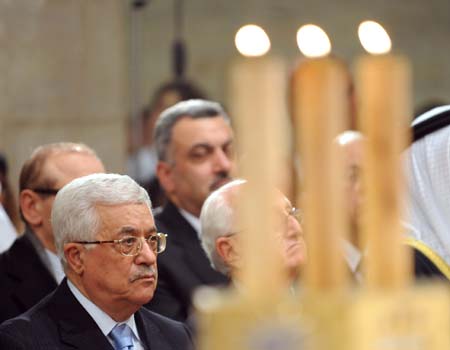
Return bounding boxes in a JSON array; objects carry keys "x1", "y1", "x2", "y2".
[{"x1": 153, "y1": 100, "x2": 230, "y2": 161}]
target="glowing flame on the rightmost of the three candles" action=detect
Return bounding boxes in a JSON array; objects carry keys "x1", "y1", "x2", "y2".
[{"x1": 358, "y1": 21, "x2": 391, "y2": 55}]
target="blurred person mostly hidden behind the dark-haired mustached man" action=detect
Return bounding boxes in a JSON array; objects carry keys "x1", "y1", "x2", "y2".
[{"x1": 127, "y1": 80, "x2": 206, "y2": 207}]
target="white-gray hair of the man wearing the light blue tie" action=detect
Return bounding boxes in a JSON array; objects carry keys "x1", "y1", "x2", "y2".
[{"x1": 51, "y1": 174, "x2": 152, "y2": 268}]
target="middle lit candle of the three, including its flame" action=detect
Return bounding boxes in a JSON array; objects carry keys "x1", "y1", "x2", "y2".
[{"x1": 293, "y1": 25, "x2": 348, "y2": 290}]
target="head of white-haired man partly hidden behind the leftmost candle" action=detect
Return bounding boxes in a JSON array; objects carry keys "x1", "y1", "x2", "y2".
[{"x1": 200, "y1": 180, "x2": 307, "y2": 286}]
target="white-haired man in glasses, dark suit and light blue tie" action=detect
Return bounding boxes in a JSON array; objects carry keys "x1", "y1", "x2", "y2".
[{"x1": 0, "y1": 174, "x2": 192, "y2": 350}]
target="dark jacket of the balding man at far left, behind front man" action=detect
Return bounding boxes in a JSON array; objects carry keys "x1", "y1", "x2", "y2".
[{"x1": 0, "y1": 232, "x2": 57, "y2": 323}]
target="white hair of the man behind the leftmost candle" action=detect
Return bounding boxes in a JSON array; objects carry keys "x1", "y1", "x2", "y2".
[{"x1": 200, "y1": 179, "x2": 246, "y2": 275}]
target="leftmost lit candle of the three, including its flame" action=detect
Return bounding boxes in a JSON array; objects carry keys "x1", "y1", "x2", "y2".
[{"x1": 230, "y1": 25, "x2": 286, "y2": 298}]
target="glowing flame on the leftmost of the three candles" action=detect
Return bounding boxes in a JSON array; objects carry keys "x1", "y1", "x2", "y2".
[{"x1": 234, "y1": 24, "x2": 270, "y2": 57}]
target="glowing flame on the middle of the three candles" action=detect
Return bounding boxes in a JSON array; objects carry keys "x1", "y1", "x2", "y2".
[{"x1": 297, "y1": 24, "x2": 331, "y2": 57}]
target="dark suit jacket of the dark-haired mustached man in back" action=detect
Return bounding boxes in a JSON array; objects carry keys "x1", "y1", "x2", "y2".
[{"x1": 146, "y1": 202, "x2": 228, "y2": 321}]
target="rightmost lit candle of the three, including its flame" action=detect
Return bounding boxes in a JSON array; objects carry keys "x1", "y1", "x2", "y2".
[{"x1": 356, "y1": 21, "x2": 412, "y2": 288}]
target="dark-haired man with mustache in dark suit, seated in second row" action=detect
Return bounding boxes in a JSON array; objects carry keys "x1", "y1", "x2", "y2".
[{"x1": 148, "y1": 100, "x2": 234, "y2": 321}]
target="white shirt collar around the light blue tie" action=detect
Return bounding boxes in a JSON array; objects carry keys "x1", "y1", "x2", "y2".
[{"x1": 67, "y1": 280, "x2": 140, "y2": 341}]
